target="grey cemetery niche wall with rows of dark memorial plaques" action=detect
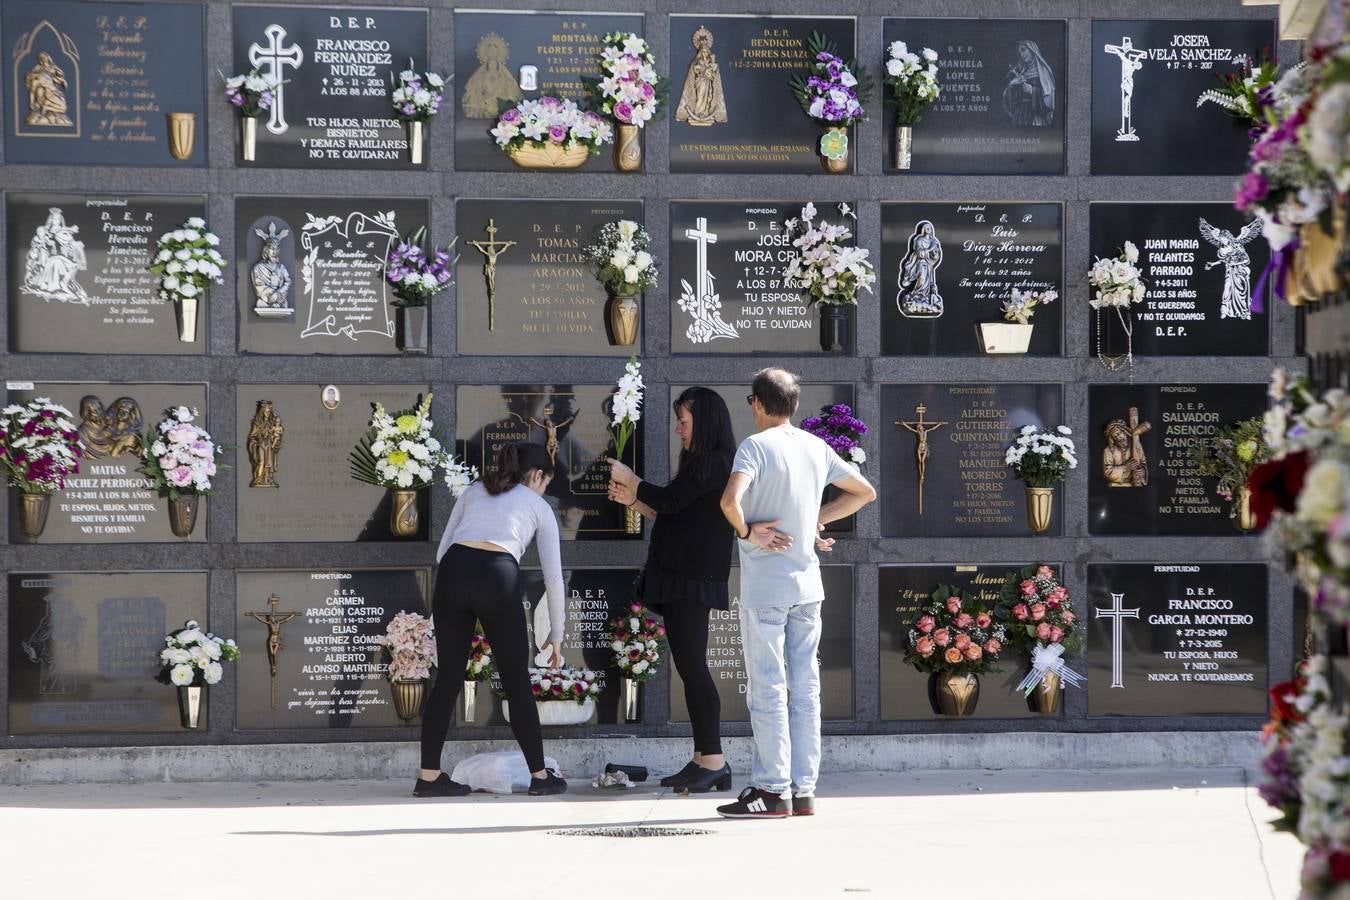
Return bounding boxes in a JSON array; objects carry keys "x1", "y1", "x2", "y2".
[{"x1": 0, "y1": 0, "x2": 1300, "y2": 749}]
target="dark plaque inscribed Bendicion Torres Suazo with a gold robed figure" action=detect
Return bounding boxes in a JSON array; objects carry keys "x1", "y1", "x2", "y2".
[{"x1": 670, "y1": 15, "x2": 858, "y2": 175}]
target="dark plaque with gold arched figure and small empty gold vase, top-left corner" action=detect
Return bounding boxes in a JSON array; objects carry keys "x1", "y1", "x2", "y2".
[{"x1": 0, "y1": 0, "x2": 207, "y2": 166}]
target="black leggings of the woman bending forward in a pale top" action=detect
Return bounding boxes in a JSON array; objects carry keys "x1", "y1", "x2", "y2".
[{"x1": 423, "y1": 544, "x2": 544, "y2": 772}]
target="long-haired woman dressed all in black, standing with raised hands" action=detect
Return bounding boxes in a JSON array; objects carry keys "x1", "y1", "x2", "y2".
[{"x1": 609, "y1": 387, "x2": 736, "y2": 793}]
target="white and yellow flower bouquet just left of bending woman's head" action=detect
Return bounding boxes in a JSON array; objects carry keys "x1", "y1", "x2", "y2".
[{"x1": 351, "y1": 394, "x2": 453, "y2": 491}]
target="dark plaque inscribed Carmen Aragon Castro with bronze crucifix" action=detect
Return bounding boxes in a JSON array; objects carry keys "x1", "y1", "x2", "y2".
[{"x1": 235, "y1": 568, "x2": 431, "y2": 729}]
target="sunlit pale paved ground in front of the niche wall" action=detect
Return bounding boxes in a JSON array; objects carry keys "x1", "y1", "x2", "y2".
[{"x1": 0, "y1": 769, "x2": 1301, "y2": 900}]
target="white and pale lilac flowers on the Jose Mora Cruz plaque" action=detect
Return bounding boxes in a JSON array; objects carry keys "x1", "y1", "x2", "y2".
[{"x1": 783, "y1": 202, "x2": 876, "y2": 305}]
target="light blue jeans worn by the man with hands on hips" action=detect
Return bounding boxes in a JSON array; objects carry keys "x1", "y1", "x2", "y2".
[{"x1": 741, "y1": 602, "x2": 821, "y2": 797}]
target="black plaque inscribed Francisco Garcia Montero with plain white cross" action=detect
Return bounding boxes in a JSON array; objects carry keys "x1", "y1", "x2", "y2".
[{"x1": 1083, "y1": 563, "x2": 1269, "y2": 716}]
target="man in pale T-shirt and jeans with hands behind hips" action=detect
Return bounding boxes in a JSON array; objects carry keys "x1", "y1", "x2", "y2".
[{"x1": 717, "y1": 368, "x2": 876, "y2": 819}]
